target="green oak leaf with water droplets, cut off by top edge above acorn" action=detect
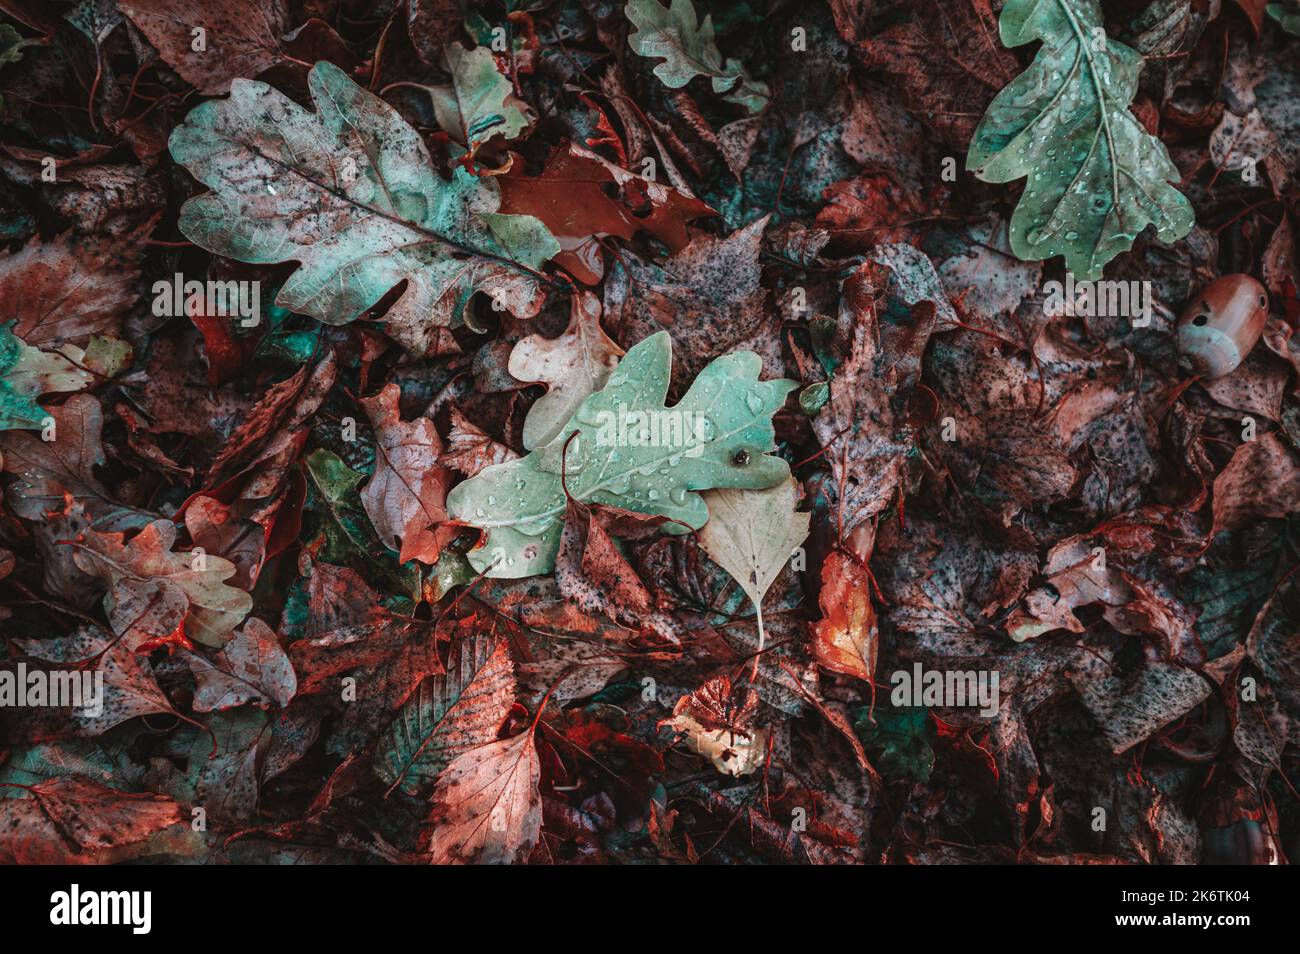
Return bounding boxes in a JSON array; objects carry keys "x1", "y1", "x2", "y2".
[{"x1": 966, "y1": 0, "x2": 1195, "y2": 281}]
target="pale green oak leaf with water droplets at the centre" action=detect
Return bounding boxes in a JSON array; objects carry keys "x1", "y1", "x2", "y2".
[{"x1": 447, "y1": 331, "x2": 794, "y2": 577}]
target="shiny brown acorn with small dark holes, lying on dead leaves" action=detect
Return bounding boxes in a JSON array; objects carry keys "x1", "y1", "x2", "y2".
[{"x1": 1178, "y1": 274, "x2": 1269, "y2": 378}]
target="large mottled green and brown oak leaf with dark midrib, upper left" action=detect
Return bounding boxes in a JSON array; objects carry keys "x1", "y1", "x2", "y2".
[{"x1": 169, "y1": 62, "x2": 559, "y2": 355}]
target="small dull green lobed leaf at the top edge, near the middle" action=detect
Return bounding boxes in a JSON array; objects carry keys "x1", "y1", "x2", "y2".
[{"x1": 623, "y1": 0, "x2": 771, "y2": 113}]
